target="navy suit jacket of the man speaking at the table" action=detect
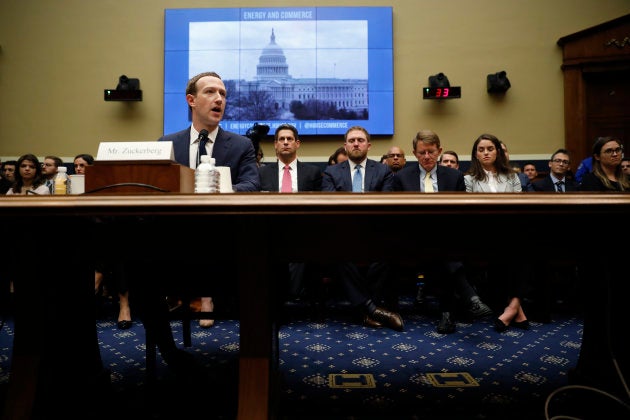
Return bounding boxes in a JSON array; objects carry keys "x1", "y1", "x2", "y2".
[{"x1": 158, "y1": 127, "x2": 260, "y2": 191}]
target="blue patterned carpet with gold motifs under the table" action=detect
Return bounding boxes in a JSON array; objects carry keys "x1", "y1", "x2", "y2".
[{"x1": 0, "y1": 296, "x2": 583, "y2": 420}]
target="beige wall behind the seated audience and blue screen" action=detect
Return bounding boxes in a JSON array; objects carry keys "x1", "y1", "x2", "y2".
[{"x1": 0, "y1": 0, "x2": 630, "y2": 161}]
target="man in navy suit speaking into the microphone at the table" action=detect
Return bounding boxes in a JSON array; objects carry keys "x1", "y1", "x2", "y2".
[{"x1": 130, "y1": 72, "x2": 260, "y2": 367}]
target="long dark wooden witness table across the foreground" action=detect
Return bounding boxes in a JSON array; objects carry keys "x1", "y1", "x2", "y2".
[{"x1": 0, "y1": 193, "x2": 630, "y2": 420}]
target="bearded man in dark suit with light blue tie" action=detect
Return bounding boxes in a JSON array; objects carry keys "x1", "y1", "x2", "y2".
[{"x1": 322, "y1": 126, "x2": 404, "y2": 331}]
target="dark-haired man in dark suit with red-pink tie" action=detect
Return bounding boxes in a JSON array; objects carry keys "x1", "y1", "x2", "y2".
[{"x1": 259, "y1": 124, "x2": 322, "y2": 302}]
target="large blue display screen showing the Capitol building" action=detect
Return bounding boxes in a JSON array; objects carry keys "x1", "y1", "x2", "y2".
[{"x1": 164, "y1": 7, "x2": 394, "y2": 135}]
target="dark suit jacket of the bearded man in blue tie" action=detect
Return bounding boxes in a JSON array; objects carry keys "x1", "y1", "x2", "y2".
[{"x1": 322, "y1": 159, "x2": 394, "y2": 191}]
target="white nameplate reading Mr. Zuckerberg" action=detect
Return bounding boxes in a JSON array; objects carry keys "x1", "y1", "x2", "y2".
[{"x1": 96, "y1": 141, "x2": 175, "y2": 161}]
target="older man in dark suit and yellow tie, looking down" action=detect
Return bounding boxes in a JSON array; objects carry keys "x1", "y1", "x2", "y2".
[{"x1": 394, "y1": 130, "x2": 492, "y2": 334}]
